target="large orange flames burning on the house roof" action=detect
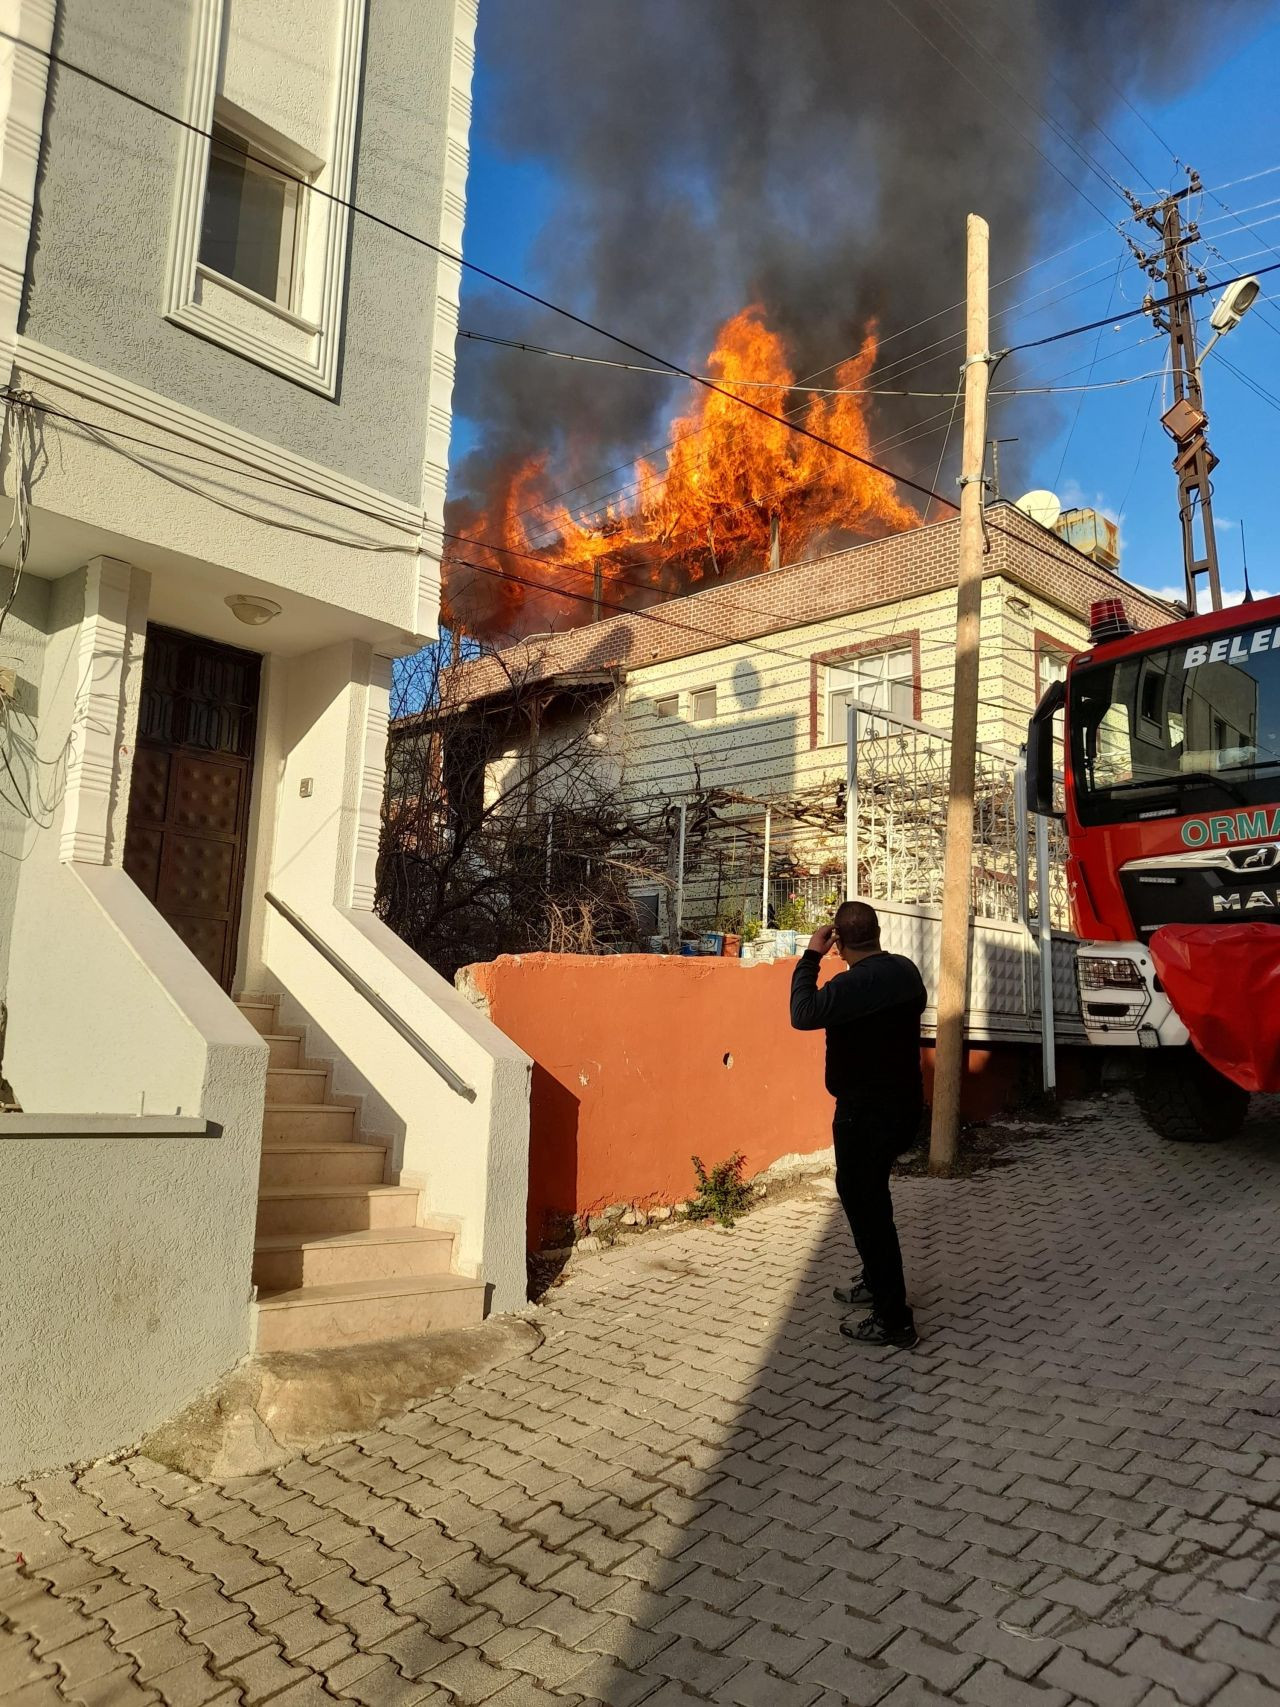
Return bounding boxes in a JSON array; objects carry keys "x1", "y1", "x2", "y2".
[{"x1": 445, "y1": 307, "x2": 920, "y2": 632}]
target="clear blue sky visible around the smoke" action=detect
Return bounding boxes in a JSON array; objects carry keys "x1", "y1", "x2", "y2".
[{"x1": 454, "y1": 3, "x2": 1280, "y2": 614}]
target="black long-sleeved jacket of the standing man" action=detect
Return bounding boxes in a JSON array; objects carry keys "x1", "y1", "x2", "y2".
[{"x1": 792, "y1": 949, "x2": 927, "y2": 1110}]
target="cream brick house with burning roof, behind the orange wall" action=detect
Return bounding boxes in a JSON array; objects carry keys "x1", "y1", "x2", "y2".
[{"x1": 386, "y1": 504, "x2": 1169, "y2": 963}]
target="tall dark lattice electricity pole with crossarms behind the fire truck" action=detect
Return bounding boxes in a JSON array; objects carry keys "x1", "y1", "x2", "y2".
[{"x1": 1130, "y1": 172, "x2": 1222, "y2": 611}]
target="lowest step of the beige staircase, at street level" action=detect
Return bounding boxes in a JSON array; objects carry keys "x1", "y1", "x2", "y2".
[{"x1": 258, "y1": 1275, "x2": 485, "y2": 1354}]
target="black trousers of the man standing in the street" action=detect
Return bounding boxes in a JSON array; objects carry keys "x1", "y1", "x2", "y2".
[{"x1": 831, "y1": 1099, "x2": 922, "y2": 1328}]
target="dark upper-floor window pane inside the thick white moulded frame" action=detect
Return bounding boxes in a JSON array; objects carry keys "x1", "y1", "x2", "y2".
[{"x1": 200, "y1": 125, "x2": 305, "y2": 309}]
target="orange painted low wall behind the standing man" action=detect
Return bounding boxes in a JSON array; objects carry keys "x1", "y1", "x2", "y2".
[{"x1": 468, "y1": 954, "x2": 1085, "y2": 1248}]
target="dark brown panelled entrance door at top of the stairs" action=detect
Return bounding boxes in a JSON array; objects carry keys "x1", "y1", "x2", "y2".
[{"x1": 125, "y1": 625, "x2": 261, "y2": 990}]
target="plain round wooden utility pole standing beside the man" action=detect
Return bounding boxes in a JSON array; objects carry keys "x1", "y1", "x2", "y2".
[{"x1": 928, "y1": 213, "x2": 992, "y2": 1173}]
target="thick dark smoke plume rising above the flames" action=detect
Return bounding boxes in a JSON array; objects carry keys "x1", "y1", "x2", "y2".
[{"x1": 451, "y1": 0, "x2": 1265, "y2": 641}]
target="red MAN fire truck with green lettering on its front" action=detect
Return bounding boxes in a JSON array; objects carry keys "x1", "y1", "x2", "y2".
[{"x1": 1027, "y1": 597, "x2": 1280, "y2": 1142}]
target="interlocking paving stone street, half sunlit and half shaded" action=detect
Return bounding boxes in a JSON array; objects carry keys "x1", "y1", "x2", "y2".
[{"x1": 0, "y1": 1101, "x2": 1280, "y2": 1707}]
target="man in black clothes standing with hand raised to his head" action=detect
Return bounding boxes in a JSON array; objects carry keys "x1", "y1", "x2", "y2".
[{"x1": 792, "y1": 901, "x2": 927, "y2": 1350}]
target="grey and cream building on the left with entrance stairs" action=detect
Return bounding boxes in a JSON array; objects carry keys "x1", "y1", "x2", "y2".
[{"x1": 0, "y1": 0, "x2": 527, "y2": 1475}]
